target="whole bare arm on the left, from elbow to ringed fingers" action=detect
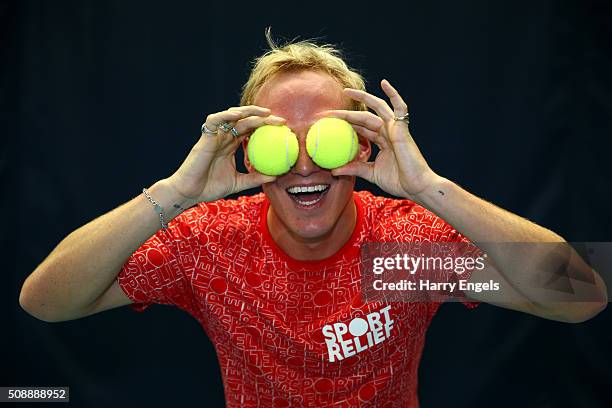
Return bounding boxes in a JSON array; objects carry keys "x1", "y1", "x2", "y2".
[{"x1": 19, "y1": 106, "x2": 285, "y2": 322}]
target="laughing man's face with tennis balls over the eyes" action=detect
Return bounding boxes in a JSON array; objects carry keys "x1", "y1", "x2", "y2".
[{"x1": 243, "y1": 71, "x2": 370, "y2": 240}]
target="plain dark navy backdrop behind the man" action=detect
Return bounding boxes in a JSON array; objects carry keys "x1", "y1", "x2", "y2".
[{"x1": 0, "y1": 0, "x2": 612, "y2": 407}]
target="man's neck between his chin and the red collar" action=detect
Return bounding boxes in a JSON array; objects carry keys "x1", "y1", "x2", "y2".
[{"x1": 266, "y1": 197, "x2": 357, "y2": 261}]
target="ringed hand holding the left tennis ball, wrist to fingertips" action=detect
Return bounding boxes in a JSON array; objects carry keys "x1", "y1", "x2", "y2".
[{"x1": 166, "y1": 105, "x2": 285, "y2": 204}]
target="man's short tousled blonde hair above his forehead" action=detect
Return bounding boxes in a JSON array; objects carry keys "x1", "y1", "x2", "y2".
[{"x1": 240, "y1": 27, "x2": 367, "y2": 110}]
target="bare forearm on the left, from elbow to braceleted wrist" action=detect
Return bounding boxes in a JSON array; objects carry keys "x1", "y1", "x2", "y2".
[{"x1": 20, "y1": 180, "x2": 191, "y2": 320}]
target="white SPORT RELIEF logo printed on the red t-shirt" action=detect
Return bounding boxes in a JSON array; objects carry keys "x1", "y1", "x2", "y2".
[{"x1": 322, "y1": 306, "x2": 393, "y2": 363}]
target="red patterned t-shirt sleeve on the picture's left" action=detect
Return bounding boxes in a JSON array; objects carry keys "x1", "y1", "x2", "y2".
[{"x1": 116, "y1": 207, "x2": 197, "y2": 315}]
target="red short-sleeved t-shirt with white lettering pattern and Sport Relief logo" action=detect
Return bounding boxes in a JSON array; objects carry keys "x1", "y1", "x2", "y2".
[{"x1": 117, "y1": 191, "x2": 476, "y2": 407}]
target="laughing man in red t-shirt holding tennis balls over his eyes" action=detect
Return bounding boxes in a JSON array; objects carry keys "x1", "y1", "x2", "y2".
[{"x1": 20, "y1": 30, "x2": 607, "y2": 407}]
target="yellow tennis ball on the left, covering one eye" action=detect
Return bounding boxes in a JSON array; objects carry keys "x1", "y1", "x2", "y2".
[{"x1": 247, "y1": 125, "x2": 299, "y2": 176}]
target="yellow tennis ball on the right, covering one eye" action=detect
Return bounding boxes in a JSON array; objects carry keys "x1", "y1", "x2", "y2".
[{"x1": 306, "y1": 118, "x2": 359, "y2": 169}]
